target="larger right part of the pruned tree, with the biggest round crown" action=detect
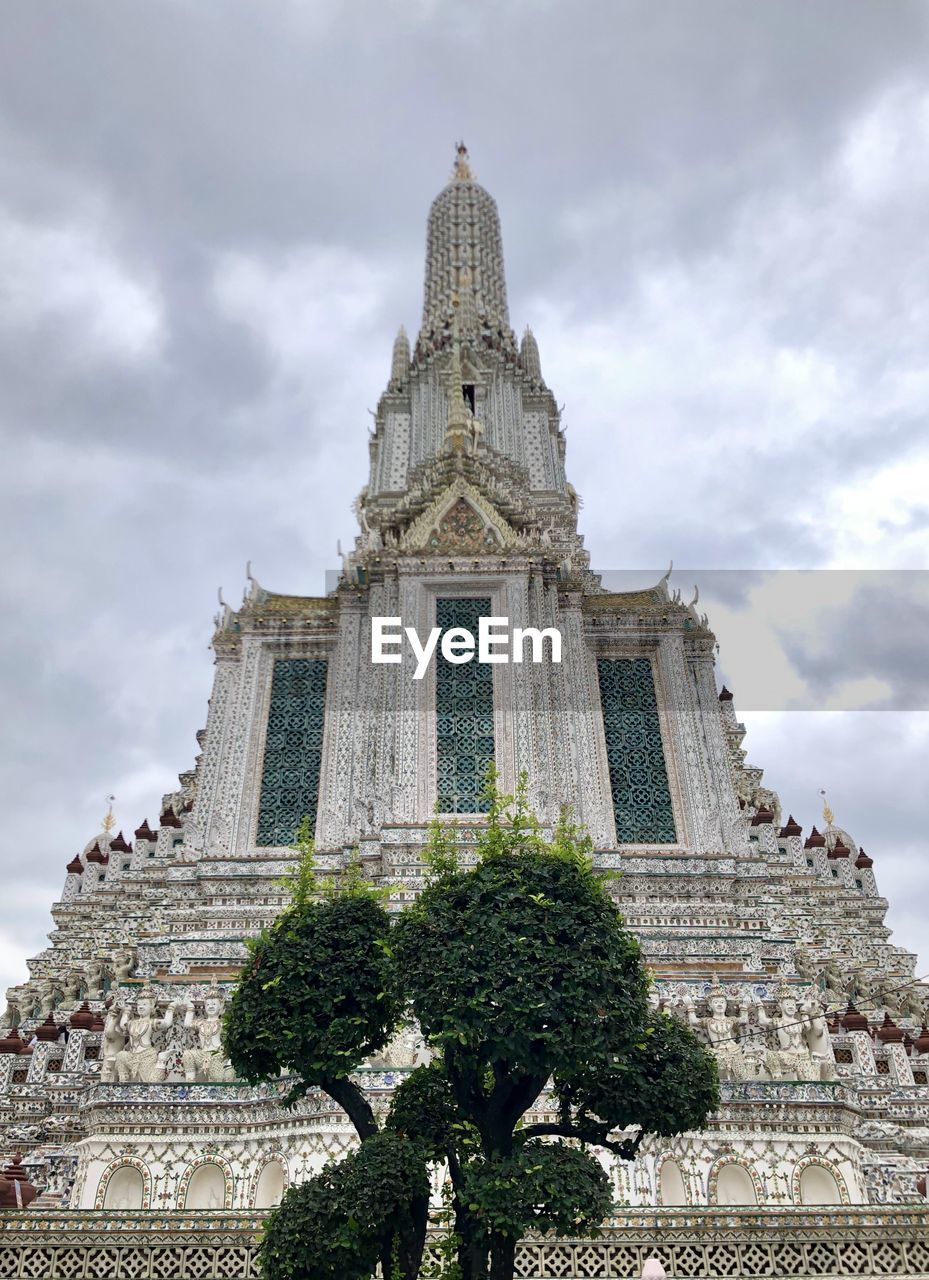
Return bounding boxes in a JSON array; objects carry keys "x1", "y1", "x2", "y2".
[{"x1": 392, "y1": 776, "x2": 718, "y2": 1280}]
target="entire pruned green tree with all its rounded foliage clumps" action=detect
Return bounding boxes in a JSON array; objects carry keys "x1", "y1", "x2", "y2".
[{"x1": 226, "y1": 772, "x2": 718, "y2": 1280}]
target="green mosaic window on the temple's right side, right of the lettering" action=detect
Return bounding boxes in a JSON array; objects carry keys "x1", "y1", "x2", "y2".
[{"x1": 596, "y1": 658, "x2": 677, "y2": 845}]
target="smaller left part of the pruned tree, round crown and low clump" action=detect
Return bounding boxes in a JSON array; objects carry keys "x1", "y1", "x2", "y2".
[{"x1": 224, "y1": 820, "x2": 429, "y2": 1280}]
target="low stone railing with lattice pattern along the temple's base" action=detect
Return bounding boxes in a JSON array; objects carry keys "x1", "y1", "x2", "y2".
[{"x1": 0, "y1": 1206, "x2": 929, "y2": 1280}]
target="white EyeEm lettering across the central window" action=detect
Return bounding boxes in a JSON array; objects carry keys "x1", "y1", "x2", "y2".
[{"x1": 371, "y1": 618, "x2": 562, "y2": 680}]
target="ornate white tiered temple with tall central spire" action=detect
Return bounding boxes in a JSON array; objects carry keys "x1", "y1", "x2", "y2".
[{"x1": 0, "y1": 146, "x2": 929, "y2": 1277}]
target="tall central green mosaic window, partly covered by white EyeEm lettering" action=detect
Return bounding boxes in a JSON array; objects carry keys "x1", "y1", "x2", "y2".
[{"x1": 435, "y1": 598, "x2": 494, "y2": 813}]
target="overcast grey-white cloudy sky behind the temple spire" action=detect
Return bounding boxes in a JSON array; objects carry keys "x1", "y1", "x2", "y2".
[{"x1": 0, "y1": 0, "x2": 929, "y2": 987}]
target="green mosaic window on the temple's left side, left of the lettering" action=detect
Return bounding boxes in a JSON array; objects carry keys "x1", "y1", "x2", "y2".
[{"x1": 257, "y1": 658, "x2": 326, "y2": 845}]
